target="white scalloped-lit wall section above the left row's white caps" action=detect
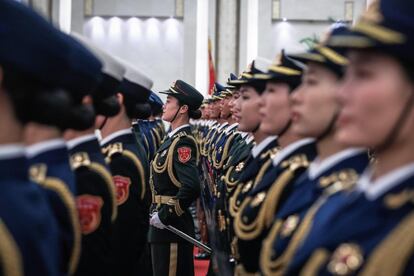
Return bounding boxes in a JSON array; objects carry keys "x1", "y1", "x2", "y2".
[{"x1": 83, "y1": 17, "x2": 184, "y2": 91}]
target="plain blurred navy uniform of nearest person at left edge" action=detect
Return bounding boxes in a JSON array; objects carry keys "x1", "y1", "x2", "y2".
[{"x1": 0, "y1": 148, "x2": 61, "y2": 276}]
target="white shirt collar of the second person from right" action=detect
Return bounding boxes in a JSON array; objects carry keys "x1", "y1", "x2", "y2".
[{"x1": 308, "y1": 148, "x2": 364, "y2": 179}]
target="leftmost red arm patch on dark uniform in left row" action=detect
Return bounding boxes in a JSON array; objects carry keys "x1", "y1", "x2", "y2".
[{"x1": 76, "y1": 195, "x2": 103, "y2": 235}]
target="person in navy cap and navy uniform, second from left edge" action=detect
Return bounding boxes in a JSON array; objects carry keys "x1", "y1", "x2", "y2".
[{"x1": 24, "y1": 33, "x2": 102, "y2": 274}]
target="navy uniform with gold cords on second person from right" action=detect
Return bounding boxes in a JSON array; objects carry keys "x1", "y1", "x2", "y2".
[{"x1": 260, "y1": 150, "x2": 368, "y2": 275}]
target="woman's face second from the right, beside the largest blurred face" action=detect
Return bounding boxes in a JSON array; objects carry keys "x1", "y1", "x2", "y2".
[{"x1": 291, "y1": 62, "x2": 339, "y2": 137}]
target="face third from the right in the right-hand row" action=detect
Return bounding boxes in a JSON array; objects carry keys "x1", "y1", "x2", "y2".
[{"x1": 260, "y1": 82, "x2": 291, "y2": 135}]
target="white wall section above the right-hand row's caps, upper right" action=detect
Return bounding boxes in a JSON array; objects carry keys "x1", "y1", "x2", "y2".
[{"x1": 258, "y1": 0, "x2": 366, "y2": 60}]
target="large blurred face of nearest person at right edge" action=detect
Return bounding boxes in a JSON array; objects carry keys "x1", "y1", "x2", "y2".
[{"x1": 336, "y1": 51, "x2": 414, "y2": 148}]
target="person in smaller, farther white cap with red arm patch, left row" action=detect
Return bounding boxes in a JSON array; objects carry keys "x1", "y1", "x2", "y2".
[{"x1": 101, "y1": 62, "x2": 152, "y2": 275}]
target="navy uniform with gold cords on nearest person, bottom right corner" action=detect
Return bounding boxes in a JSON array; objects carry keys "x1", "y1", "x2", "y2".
[{"x1": 287, "y1": 164, "x2": 414, "y2": 276}]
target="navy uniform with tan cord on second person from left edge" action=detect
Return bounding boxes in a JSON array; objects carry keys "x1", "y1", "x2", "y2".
[{"x1": 29, "y1": 139, "x2": 81, "y2": 274}]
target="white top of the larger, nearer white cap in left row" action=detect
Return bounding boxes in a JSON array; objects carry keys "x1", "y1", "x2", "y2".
[{"x1": 71, "y1": 32, "x2": 126, "y2": 81}]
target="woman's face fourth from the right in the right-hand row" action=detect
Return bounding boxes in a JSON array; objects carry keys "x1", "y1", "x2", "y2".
[{"x1": 238, "y1": 85, "x2": 262, "y2": 132}]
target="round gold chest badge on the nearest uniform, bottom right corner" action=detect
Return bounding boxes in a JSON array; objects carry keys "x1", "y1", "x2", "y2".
[{"x1": 328, "y1": 243, "x2": 363, "y2": 275}]
